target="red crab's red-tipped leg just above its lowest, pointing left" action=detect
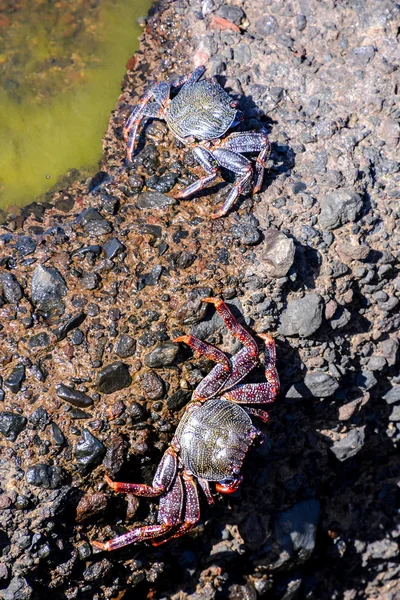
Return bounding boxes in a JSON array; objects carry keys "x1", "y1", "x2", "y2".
[{"x1": 106, "y1": 448, "x2": 178, "y2": 498}]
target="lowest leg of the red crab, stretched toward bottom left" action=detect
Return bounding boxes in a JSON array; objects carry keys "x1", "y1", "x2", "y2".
[{"x1": 92, "y1": 475, "x2": 183, "y2": 550}]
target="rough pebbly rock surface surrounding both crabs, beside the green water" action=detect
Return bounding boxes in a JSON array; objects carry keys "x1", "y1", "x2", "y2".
[{"x1": 0, "y1": 0, "x2": 400, "y2": 600}]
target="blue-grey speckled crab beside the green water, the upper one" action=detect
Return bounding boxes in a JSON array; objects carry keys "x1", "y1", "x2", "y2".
[{"x1": 123, "y1": 66, "x2": 270, "y2": 219}]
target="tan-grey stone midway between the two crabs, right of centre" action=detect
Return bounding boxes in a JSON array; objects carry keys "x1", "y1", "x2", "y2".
[{"x1": 255, "y1": 229, "x2": 295, "y2": 278}]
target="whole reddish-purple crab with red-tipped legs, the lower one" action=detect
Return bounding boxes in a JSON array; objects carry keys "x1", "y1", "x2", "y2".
[{"x1": 92, "y1": 298, "x2": 279, "y2": 550}]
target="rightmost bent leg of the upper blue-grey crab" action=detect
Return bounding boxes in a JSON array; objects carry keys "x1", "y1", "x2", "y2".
[{"x1": 219, "y1": 131, "x2": 271, "y2": 194}]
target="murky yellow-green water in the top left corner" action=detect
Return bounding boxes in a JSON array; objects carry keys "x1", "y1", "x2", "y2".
[{"x1": 0, "y1": 0, "x2": 151, "y2": 208}]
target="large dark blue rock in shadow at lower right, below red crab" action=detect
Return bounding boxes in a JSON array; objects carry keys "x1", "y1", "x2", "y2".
[{"x1": 274, "y1": 498, "x2": 320, "y2": 564}]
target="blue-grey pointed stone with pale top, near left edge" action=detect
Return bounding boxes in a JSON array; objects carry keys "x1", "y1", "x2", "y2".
[{"x1": 31, "y1": 264, "x2": 68, "y2": 318}]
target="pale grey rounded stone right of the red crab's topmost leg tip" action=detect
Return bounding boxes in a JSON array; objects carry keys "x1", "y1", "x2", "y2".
[{"x1": 279, "y1": 293, "x2": 324, "y2": 337}]
